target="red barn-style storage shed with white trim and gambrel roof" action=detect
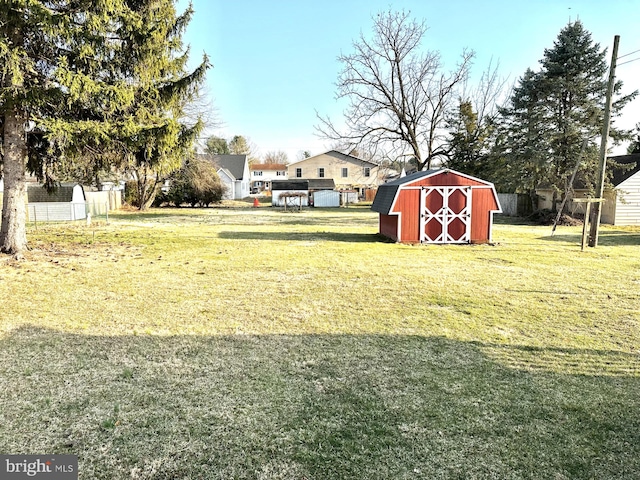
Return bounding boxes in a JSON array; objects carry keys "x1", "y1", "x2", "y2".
[{"x1": 371, "y1": 169, "x2": 502, "y2": 243}]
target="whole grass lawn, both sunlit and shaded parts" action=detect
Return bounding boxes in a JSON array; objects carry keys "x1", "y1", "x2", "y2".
[{"x1": 0, "y1": 207, "x2": 640, "y2": 479}]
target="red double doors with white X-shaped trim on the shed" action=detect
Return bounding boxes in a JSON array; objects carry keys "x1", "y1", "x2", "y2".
[{"x1": 420, "y1": 187, "x2": 471, "y2": 243}]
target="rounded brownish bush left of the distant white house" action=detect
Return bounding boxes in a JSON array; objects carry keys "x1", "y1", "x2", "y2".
[{"x1": 166, "y1": 159, "x2": 226, "y2": 207}]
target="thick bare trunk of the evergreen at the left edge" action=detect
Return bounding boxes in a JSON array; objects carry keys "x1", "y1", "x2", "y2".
[{"x1": 0, "y1": 109, "x2": 27, "y2": 258}]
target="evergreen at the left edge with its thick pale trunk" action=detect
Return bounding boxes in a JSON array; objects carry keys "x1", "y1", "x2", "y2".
[{"x1": 0, "y1": 0, "x2": 132, "y2": 257}]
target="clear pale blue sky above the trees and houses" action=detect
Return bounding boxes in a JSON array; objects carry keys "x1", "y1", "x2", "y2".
[{"x1": 177, "y1": 0, "x2": 640, "y2": 162}]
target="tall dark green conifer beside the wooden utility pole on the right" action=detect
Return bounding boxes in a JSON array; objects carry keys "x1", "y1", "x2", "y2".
[{"x1": 502, "y1": 21, "x2": 635, "y2": 205}]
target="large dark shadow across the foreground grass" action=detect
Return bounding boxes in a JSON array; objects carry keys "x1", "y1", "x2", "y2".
[{"x1": 0, "y1": 327, "x2": 640, "y2": 479}]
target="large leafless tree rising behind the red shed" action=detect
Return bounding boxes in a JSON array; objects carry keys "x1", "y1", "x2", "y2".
[{"x1": 316, "y1": 11, "x2": 474, "y2": 169}]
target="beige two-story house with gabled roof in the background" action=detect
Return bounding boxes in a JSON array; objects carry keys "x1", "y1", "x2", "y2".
[{"x1": 287, "y1": 150, "x2": 384, "y2": 199}]
